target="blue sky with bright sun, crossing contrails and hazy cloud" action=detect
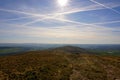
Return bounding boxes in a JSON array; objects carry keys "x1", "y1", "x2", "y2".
[{"x1": 0, "y1": 0, "x2": 120, "y2": 44}]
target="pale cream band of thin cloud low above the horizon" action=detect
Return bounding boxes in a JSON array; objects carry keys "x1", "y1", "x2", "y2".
[{"x1": 0, "y1": 22, "x2": 120, "y2": 43}]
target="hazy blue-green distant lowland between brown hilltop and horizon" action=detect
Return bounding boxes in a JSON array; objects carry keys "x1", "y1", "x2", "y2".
[{"x1": 0, "y1": 43, "x2": 120, "y2": 56}]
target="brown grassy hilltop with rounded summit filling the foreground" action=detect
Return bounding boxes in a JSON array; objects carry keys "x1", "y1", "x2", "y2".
[{"x1": 0, "y1": 46, "x2": 120, "y2": 80}]
